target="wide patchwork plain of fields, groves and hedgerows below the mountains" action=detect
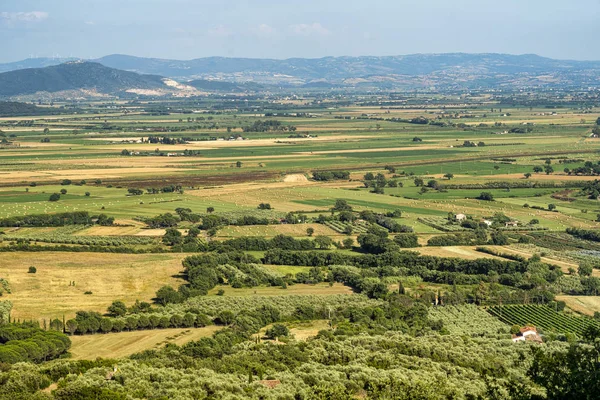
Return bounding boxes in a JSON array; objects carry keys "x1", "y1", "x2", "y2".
[{"x1": 0, "y1": 91, "x2": 600, "y2": 399}]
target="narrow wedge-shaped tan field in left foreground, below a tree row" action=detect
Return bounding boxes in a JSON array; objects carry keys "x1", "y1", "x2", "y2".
[{"x1": 70, "y1": 326, "x2": 220, "y2": 360}]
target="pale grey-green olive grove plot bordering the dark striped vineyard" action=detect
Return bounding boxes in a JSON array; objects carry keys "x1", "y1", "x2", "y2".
[{"x1": 429, "y1": 304, "x2": 510, "y2": 336}]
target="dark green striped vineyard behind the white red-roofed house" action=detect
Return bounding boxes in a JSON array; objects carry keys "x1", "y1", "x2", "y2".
[{"x1": 488, "y1": 304, "x2": 600, "y2": 336}]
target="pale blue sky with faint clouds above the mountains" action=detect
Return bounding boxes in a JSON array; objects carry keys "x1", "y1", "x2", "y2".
[{"x1": 0, "y1": 0, "x2": 600, "y2": 62}]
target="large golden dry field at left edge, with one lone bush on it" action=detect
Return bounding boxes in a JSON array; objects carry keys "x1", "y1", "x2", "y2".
[{"x1": 0, "y1": 252, "x2": 186, "y2": 320}]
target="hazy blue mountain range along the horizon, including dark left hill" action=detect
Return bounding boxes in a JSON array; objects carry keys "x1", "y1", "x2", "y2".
[{"x1": 0, "y1": 53, "x2": 600, "y2": 97}]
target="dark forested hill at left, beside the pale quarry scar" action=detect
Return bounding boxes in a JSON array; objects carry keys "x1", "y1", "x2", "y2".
[{"x1": 0, "y1": 62, "x2": 167, "y2": 97}]
